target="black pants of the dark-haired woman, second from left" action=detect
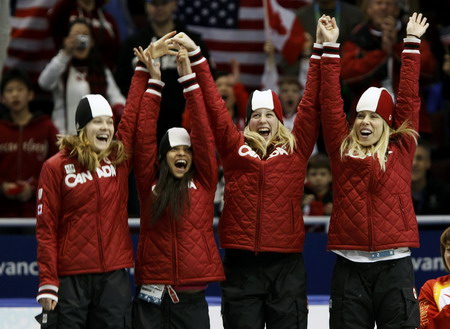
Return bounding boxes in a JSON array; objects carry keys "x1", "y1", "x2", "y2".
[{"x1": 133, "y1": 288, "x2": 210, "y2": 329}]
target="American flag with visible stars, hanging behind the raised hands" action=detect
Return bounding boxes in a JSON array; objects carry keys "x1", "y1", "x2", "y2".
[{"x1": 178, "y1": 0, "x2": 311, "y2": 89}]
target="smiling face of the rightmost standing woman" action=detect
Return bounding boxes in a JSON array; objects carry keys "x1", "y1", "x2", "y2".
[{"x1": 353, "y1": 111, "x2": 384, "y2": 146}]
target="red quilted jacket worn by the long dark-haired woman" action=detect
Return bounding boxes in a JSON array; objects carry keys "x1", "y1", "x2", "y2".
[{"x1": 135, "y1": 75, "x2": 225, "y2": 285}]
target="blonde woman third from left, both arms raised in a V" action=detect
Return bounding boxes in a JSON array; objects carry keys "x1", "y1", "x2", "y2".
[{"x1": 173, "y1": 15, "x2": 321, "y2": 329}]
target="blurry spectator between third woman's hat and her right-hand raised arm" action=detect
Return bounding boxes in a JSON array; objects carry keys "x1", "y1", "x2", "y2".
[{"x1": 278, "y1": 76, "x2": 303, "y2": 130}]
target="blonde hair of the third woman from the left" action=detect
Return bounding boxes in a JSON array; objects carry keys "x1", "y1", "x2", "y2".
[{"x1": 244, "y1": 121, "x2": 295, "y2": 159}]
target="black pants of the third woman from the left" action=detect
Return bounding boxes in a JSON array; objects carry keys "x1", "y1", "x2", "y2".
[{"x1": 221, "y1": 250, "x2": 308, "y2": 329}]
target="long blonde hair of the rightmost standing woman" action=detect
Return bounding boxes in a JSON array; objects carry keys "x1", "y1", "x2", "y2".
[{"x1": 340, "y1": 120, "x2": 419, "y2": 171}]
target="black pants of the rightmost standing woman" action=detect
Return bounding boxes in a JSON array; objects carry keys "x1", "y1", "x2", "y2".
[{"x1": 330, "y1": 256, "x2": 420, "y2": 329}]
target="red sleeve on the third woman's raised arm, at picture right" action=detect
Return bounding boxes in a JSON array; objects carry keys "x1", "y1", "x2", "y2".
[{"x1": 292, "y1": 44, "x2": 322, "y2": 161}]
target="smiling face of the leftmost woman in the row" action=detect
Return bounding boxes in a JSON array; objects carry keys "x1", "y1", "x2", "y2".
[{"x1": 85, "y1": 115, "x2": 114, "y2": 153}]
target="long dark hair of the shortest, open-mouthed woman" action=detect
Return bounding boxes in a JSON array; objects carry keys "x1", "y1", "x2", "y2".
[{"x1": 149, "y1": 157, "x2": 194, "y2": 225}]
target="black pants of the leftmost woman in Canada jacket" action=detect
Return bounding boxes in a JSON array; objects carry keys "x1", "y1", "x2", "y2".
[{"x1": 55, "y1": 269, "x2": 132, "y2": 329}]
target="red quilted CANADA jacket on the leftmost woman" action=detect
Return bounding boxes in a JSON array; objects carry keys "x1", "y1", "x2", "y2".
[{"x1": 36, "y1": 65, "x2": 148, "y2": 299}]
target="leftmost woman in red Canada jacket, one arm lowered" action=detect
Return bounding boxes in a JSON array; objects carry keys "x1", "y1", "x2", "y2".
[{"x1": 36, "y1": 62, "x2": 148, "y2": 329}]
